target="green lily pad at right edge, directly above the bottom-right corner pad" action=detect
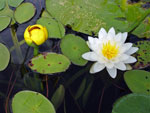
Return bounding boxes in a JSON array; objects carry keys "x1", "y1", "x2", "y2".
[{"x1": 124, "y1": 70, "x2": 150, "y2": 95}]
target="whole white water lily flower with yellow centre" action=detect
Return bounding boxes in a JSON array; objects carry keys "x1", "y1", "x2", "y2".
[{"x1": 82, "y1": 27, "x2": 138, "y2": 78}]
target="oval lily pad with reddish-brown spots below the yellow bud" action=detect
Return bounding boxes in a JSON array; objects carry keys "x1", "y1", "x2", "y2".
[{"x1": 28, "y1": 53, "x2": 70, "y2": 74}]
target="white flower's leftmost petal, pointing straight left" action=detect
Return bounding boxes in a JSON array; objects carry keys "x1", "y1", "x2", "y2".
[{"x1": 82, "y1": 52, "x2": 98, "y2": 61}]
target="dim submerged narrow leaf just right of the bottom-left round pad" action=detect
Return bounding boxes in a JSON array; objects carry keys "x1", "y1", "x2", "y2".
[{"x1": 51, "y1": 85, "x2": 65, "y2": 109}]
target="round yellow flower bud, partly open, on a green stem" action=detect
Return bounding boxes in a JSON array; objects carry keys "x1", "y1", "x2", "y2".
[{"x1": 24, "y1": 24, "x2": 48, "y2": 47}]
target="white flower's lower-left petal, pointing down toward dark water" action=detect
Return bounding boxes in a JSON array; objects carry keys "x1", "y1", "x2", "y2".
[{"x1": 90, "y1": 62, "x2": 105, "y2": 73}]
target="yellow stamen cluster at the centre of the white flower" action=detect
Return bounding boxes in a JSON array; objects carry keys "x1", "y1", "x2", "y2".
[{"x1": 102, "y1": 41, "x2": 119, "y2": 60}]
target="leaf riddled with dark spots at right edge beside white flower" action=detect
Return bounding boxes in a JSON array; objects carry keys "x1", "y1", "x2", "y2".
[{"x1": 132, "y1": 41, "x2": 150, "y2": 69}]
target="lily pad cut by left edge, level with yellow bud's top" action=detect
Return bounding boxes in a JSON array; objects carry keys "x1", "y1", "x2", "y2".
[{"x1": 0, "y1": 16, "x2": 11, "y2": 31}]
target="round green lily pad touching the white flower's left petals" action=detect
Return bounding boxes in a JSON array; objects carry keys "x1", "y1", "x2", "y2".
[{"x1": 60, "y1": 34, "x2": 90, "y2": 66}]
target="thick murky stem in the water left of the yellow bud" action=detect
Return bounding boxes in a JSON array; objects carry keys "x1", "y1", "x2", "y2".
[{"x1": 11, "y1": 25, "x2": 23, "y2": 63}]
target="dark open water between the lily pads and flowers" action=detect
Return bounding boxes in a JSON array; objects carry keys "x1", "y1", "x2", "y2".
[{"x1": 0, "y1": 0, "x2": 148, "y2": 113}]
